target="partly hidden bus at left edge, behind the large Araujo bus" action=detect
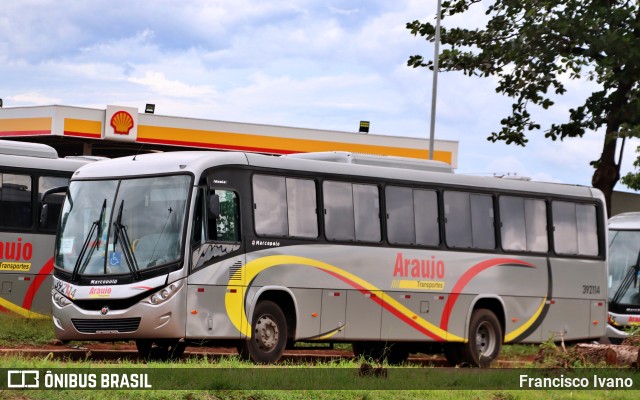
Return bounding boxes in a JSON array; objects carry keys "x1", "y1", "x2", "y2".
[{"x1": 0, "y1": 140, "x2": 95, "y2": 318}]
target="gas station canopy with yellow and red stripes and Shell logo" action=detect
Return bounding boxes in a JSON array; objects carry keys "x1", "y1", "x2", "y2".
[{"x1": 0, "y1": 105, "x2": 458, "y2": 169}]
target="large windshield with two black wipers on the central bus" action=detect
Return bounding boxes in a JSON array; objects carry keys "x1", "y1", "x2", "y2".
[{"x1": 55, "y1": 175, "x2": 191, "y2": 277}]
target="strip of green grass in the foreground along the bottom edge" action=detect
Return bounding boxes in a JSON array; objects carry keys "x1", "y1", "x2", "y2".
[{"x1": 0, "y1": 357, "x2": 638, "y2": 400}]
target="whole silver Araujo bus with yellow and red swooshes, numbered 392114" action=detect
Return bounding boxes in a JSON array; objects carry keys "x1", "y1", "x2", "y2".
[{"x1": 52, "y1": 152, "x2": 607, "y2": 366}]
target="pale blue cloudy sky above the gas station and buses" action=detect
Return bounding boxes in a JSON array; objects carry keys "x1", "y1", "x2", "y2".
[{"x1": 0, "y1": 0, "x2": 640, "y2": 191}]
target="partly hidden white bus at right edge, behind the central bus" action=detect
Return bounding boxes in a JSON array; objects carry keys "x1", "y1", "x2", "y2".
[{"x1": 607, "y1": 212, "x2": 640, "y2": 343}]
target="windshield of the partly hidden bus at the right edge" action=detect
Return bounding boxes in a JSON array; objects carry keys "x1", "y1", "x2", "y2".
[{"x1": 609, "y1": 231, "x2": 640, "y2": 304}]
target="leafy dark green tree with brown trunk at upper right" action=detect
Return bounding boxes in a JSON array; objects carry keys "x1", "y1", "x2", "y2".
[{"x1": 407, "y1": 0, "x2": 640, "y2": 216}]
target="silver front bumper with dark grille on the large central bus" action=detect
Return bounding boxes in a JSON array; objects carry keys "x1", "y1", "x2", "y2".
[{"x1": 52, "y1": 285, "x2": 187, "y2": 340}]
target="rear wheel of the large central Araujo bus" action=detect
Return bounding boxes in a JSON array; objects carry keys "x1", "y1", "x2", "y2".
[{"x1": 461, "y1": 308, "x2": 503, "y2": 368}]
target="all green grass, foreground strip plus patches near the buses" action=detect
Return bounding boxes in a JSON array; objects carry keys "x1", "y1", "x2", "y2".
[{"x1": 0, "y1": 314, "x2": 640, "y2": 400}]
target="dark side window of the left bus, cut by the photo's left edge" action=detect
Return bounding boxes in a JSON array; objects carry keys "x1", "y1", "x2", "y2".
[{"x1": 0, "y1": 174, "x2": 32, "y2": 228}]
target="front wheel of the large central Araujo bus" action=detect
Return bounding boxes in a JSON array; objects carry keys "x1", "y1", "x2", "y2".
[{"x1": 238, "y1": 300, "x2": 287, "y2": 364}]
